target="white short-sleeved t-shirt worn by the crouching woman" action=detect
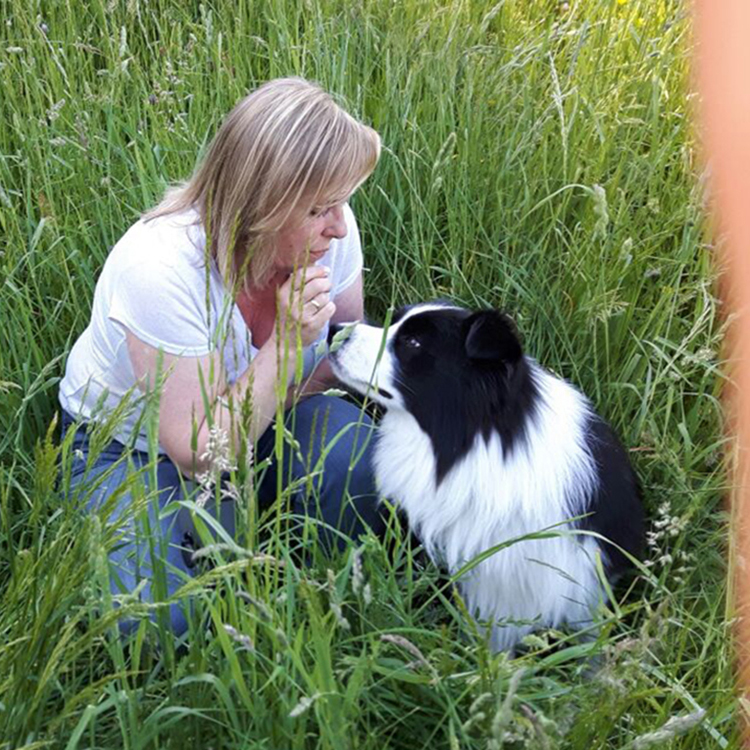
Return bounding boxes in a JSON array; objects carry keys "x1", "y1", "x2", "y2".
[{"x1": 60, "y1": 205, "x2": 362, "y2": 450}]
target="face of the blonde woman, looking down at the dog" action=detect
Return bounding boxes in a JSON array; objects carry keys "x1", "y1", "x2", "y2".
[{"x1": 275, "y1": 203, "x2": 346, "y2": 276}]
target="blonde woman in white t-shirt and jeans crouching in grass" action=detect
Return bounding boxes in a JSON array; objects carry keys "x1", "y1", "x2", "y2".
[{"x1": 60, "y1": 78, "x2": 383, "y2": 634}]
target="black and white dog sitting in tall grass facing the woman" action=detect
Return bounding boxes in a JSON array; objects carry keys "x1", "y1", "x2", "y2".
[{"x1": 329, "y1": 304, "x2": 643, "y2": 650}]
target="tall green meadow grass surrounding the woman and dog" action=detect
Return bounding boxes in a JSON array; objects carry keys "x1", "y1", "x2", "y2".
[{"x1": 0, "y1": 0, "x2": 738, "y2": 750}]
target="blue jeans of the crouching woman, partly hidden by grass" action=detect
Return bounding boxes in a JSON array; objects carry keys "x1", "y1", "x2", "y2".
[{"x1": 62, "y1": 396, "x2": 385, "y2": 635}]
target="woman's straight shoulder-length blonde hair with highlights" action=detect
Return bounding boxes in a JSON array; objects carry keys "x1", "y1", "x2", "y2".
[{"x1": 144, "y1": 78, "x2": 380, "y2": 287}]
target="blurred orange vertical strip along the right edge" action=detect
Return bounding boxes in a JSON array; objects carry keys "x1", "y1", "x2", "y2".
[{"x1": 694, "y1": 0, "x2": 750, "y2": 748}]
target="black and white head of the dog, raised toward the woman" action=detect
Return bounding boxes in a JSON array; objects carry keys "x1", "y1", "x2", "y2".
[{"x1": 329, "y1": 303, "x2": 538, "y2": 481}]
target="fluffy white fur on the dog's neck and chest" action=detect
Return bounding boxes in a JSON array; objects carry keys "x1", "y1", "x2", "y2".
[{"x1": 375, "y1": 359, "x2": 601, "y2": 649}]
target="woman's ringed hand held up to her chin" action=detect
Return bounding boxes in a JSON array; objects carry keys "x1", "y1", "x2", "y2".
[{"x1": 274, "y1": 266, "x2": 336, "y2": 347}]
